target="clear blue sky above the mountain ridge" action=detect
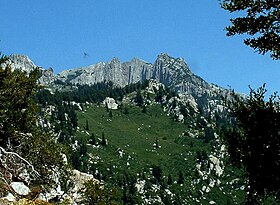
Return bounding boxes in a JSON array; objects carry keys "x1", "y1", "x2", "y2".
[{"x1": 0, "y1": 0, "x2": 280, "y2": 93}]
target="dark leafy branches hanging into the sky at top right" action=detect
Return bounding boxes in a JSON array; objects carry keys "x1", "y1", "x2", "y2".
[{"x1": 221, "y1": 0, "x2": 280, "y2": 59}]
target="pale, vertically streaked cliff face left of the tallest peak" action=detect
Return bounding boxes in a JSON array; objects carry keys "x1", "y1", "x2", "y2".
[{"x1": 56, "y1": 58, "x2": 152, "y2": 87}]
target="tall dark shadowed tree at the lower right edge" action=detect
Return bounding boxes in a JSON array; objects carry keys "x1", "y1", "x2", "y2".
[{"x1": 224, "y1": 86, "x2": 280, "y2": 204}]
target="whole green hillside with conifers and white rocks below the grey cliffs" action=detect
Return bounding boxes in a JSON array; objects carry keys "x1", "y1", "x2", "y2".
[{"x1": 34, "y1": 82, "x2": 250, "y2": 205}]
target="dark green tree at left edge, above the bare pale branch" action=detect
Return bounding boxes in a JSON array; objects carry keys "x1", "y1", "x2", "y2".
[{"x1": 0, "y1": 57, "x2": 39, "y2": 147}]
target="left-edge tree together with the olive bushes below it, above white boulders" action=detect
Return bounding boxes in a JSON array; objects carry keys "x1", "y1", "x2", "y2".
[{"x1": 0, "y1": 53, "x2": 67, "y2": 189}]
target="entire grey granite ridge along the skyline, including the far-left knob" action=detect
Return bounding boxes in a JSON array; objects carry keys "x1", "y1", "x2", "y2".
[{"x1": 11, "y1": 53, "x2": 226, "y2": 95}]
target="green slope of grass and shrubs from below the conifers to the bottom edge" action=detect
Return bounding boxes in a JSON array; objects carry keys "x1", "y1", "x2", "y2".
[{"x1": 76, "y1": 101, "x2": 244, "y2": 204}]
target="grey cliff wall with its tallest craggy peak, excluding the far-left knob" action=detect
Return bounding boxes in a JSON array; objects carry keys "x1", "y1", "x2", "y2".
[{"x1": 55, "y1": 54, "x2": 201, "y2": 91}]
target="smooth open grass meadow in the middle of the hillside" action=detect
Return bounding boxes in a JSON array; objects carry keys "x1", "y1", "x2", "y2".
[{"x1": 77, "y1": 105, "x2": 196, "y2": 175}]
